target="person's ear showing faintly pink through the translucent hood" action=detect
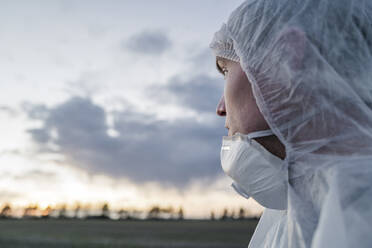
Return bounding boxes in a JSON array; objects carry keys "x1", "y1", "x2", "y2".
[{"x1": 276, "y1": 27, "x2": 306, "y2": 70}]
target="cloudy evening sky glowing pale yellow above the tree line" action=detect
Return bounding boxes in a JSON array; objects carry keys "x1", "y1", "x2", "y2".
[{"x1": 0, "y1": 0, "x2": 262, "y2": 218}]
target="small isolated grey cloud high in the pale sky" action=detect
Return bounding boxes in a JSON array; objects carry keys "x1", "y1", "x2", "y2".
[{"x1": 124, "y1": 30, "x2": 172, "y2": 55}]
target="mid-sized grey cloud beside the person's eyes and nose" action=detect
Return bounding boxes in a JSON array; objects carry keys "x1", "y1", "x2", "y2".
[{"x1": 148, "y1": 74, "x2": 223, "y2": 113}]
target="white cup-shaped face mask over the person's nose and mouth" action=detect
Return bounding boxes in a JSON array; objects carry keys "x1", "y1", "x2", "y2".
[{"x1": 221, "y1": 130, "x2": 288, "y2": 210}]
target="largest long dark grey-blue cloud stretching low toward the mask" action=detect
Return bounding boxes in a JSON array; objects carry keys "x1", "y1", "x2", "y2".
[{"x1": 29, "y1": 97, "x2": 224, "y2": 186}]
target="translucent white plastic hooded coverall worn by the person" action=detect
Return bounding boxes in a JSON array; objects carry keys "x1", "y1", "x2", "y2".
[{"x1": 211, "y1": 0, "x2": 372, "y2": 248}]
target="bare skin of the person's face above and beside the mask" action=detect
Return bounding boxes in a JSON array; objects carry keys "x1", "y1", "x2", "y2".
[{"x1": 216, "y1": 58, "x2": 285, "y2": 159}]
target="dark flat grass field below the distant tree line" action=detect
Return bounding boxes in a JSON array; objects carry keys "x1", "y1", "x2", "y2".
[{"x1": 0, "y1": 220, "x2": 257, "y2": 248}]
